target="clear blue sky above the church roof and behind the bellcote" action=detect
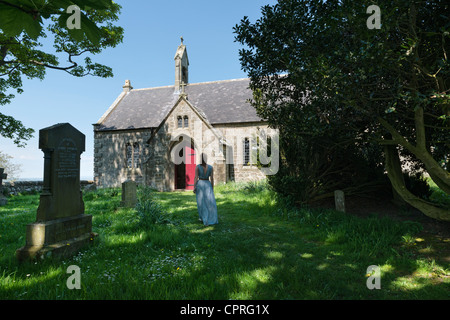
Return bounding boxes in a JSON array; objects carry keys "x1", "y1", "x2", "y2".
[{"x1": 0, "y1": 0, "x2": 276, "y2": 179}]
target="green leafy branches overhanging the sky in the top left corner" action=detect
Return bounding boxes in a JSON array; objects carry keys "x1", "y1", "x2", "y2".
[{"x1": 0, "y1": 0, "x2": 123, "y2": 146}]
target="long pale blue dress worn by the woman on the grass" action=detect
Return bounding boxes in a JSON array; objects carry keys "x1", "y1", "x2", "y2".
[{"x1": 195, "y1": 165, "x2": 219, "y2": 226}]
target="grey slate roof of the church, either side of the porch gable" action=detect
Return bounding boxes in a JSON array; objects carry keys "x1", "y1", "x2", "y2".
[{"x1": 96, "y1": 79, "x2": 262, "y2": 131}]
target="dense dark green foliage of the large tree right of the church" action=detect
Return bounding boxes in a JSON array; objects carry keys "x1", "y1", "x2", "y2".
[{"x1": 234, "y1": 0, "x2": 450, "y2": 210}]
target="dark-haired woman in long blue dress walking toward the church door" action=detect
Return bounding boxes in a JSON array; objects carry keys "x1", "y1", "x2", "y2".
[{"x1": 194, "y1": 153, "x2": 219, "y2": 226}]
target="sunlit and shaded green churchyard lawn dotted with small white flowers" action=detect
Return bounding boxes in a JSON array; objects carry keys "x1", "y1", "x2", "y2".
[{"x1": 0, "y1": 184, "x2": 450, "y2": 300}]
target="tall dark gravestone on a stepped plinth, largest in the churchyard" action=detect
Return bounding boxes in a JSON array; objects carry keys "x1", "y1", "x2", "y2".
[{"x1": 16, "y1": 123, "x2": 96, "y2": 260}]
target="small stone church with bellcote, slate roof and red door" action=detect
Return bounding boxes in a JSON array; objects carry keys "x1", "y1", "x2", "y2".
[{"x1": 94, "y1": 40, "x2": 275, "y2": 191}]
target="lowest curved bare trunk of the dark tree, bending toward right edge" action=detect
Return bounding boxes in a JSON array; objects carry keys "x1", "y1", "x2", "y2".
[{"x1": 384, "y1": 145, "x2": 450, "y2": 221}]
